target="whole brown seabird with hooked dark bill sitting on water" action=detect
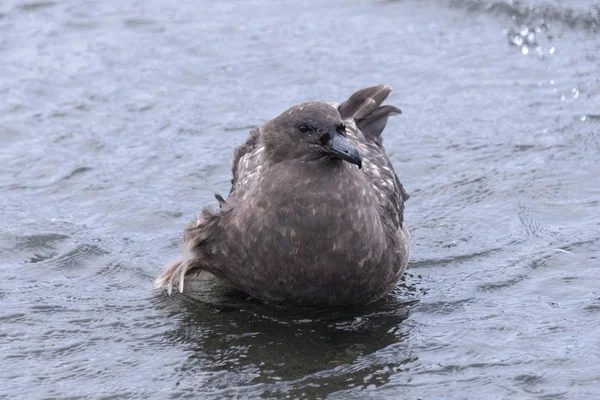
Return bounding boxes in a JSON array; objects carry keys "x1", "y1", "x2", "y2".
[{"x1": 153, "y1": 85, "x2": 410, "y2": 307}]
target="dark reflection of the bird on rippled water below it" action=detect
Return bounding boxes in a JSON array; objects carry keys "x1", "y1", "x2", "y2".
[{"x1": 157, "y1": 276, "x2": 418, "y2": 397}]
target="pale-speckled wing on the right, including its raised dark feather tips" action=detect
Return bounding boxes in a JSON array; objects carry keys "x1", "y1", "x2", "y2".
[{"x1": 338, "y1": 85, "x2": 409, "y2": 226}]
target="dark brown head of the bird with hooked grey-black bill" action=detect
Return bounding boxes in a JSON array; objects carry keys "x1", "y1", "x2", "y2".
[{"x1": 261, "y1": 102, "x2": 362, "y2": 168}]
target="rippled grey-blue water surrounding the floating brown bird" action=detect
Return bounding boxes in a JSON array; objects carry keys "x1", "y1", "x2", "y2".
[{"x1": 0, "y1": 0, "x2": 600, "y2": 399}]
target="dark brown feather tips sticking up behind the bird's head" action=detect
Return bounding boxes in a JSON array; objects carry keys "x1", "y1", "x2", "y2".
[{"x1": 338, "y1": 85, "x2": 402, "y2": 143}]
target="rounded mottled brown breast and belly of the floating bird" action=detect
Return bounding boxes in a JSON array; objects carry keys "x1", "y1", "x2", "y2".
[{"x1": 224, "y1": 161, "x2": 402, "y2": 304}]
